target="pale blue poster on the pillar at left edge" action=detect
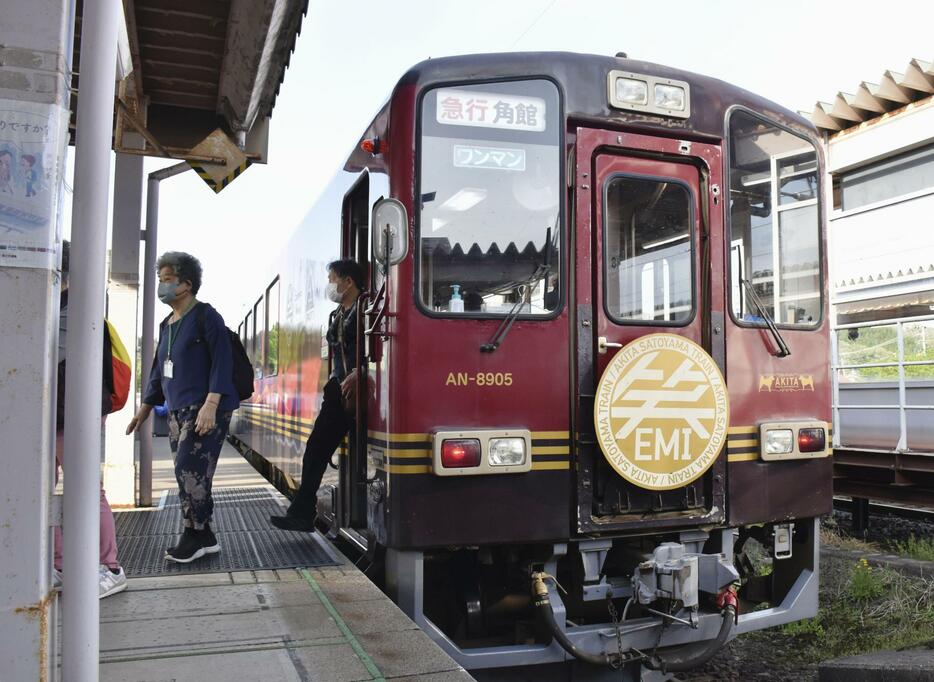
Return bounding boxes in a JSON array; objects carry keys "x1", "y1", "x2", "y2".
[{"x1": 0, "y1": 99, "x2": 68, "y2": 269}]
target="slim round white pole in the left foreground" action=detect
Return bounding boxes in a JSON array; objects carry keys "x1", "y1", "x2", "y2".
[{"x1": 62, "y1": 0, "x2": 121, "y2": 682}]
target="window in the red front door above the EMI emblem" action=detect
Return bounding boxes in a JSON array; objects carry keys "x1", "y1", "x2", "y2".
[{"x1": 605, "y1": 175, "x2": 694, "y2": 324}]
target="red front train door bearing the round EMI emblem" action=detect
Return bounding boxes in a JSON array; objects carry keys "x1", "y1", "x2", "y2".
[{"x1": 576, "y1": 129, "x2": 727, "y2": 532}]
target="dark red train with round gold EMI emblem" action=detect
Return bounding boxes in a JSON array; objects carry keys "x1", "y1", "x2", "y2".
[{"x1": 229, "y1": 53, "x2": 832, "y2": 679}]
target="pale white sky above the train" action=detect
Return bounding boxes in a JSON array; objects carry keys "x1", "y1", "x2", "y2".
[{"x1": 65, "y1": 0, "x2": 934, "y2": 328}]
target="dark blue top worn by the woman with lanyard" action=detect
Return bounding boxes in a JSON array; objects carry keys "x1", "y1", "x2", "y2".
[{"x1": 143, "y1": 303, "x2": 240, "y2": 413}]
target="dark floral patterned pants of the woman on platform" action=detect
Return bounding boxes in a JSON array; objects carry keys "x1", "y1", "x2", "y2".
[{"x1": 169, "y1": 405, "x2": 233, "y2": 530}]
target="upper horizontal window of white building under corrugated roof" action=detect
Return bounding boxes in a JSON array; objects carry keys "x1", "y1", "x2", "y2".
[{"x1": 840, "y1": 145, "x2": 934, "y2": 211}]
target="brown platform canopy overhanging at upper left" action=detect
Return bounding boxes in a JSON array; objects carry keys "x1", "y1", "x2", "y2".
[{"x1": 71, "y1": 0, "x2": 308, "y2": 162}]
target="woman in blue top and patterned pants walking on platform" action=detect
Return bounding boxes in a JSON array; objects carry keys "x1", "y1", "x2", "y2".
[{"x1": 127, "y1": 251, "x2": 240, "y2": 563}]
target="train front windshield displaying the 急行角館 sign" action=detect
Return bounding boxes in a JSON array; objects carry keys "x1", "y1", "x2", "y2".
[{"x1": 418, "y1": 80, "x2": 561, "y2": 316}]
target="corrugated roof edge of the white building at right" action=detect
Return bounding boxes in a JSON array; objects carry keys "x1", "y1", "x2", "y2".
[{"x1": 799, "y1": 59, "x2": 934, "y2": 134}]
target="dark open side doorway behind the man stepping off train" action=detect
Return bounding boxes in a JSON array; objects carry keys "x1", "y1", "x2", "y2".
[{"x1": 339, "y1": 172, "x2": 370, "y2": 537}]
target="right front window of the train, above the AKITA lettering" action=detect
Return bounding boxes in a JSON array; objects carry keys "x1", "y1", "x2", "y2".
[{"x1": 730, "y1": 111, "x2": 822, "y2": 326}]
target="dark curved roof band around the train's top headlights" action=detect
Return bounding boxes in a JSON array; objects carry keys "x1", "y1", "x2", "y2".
[{"x1": 345, "y1": 52, "x2": 819, "y2": 171}]
